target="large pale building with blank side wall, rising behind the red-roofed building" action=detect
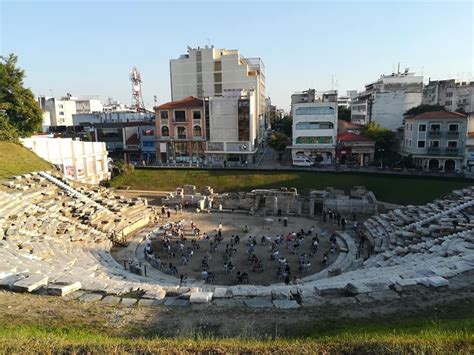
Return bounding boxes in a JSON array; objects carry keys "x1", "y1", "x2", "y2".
[{"x1": 351, "y1": 69, "x2": 423, "y2": 131}]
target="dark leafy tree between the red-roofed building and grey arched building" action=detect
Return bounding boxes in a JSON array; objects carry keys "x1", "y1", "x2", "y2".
[{"x1": 361, "y1": 122, "x2": 399, "y2": 163}]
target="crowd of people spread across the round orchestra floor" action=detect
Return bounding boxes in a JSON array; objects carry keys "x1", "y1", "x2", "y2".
[{"x1": 145, "y1": 210, "x2": 347, "y2": 284}]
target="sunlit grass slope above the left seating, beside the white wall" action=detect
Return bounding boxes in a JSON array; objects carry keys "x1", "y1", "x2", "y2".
[{"x1": 0, "y1": 141, "x2": 51, "y2": 180}]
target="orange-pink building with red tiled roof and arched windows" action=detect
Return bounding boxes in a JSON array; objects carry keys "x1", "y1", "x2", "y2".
[{"x1": 155, "y1": 96, "x2": 208, "y2": 163}]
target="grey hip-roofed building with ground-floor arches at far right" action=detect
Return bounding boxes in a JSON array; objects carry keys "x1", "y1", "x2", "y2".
[{"x1": 402, "y1": 111, "x2": 467, "y2": 172}]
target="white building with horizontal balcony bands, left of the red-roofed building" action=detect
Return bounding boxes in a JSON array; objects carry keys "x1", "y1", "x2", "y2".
[{"x1": 291, "y1": 89, "x2": 338, "y2": 164}]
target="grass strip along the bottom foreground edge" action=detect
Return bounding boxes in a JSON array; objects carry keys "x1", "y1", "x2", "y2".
[{"x1": 0, "y1": 319, "x2": 474, "y2": 354}]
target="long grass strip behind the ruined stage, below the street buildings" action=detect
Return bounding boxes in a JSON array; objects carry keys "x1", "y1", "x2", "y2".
[{"x1": 112, "y1": 169, "x2": 473, "y2": 204}]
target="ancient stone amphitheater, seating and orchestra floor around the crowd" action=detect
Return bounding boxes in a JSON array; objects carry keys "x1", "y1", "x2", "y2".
[{"x1": 0, "y1": 172, "x2": 474, "y2": 308}]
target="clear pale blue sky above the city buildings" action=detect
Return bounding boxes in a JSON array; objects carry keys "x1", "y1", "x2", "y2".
[{"x1": 0, "y1": 0, "x2": 474, "y2": 109}]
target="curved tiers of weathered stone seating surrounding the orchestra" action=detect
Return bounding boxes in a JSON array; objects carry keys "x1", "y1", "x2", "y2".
[{"x1": 0, "y1": 174, "x2": 474, "y2": 307}]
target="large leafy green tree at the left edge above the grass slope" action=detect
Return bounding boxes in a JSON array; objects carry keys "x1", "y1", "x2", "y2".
[{"x1": 0, "y1": 54, "x2": 43, "y2": 136}]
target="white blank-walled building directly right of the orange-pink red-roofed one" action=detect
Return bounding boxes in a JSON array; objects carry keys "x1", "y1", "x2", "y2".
[{"x1": 205, "y1": 90, "x2": 259, "y2": 165}]
